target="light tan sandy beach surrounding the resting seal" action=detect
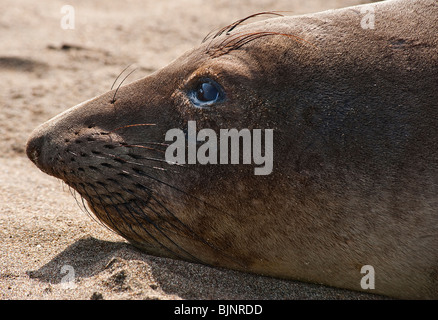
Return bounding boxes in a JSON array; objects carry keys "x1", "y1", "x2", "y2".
[{"x1": 0, "y1": 0, "x2": 382, "y2": 300}]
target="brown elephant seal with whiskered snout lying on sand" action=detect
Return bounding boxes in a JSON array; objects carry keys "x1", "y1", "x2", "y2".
[{"x1": 27, "y1": 0, "x2": 438, "y2": 299}]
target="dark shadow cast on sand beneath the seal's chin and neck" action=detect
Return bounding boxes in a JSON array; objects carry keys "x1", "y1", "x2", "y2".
[{"x1": 26, "y1": 237, "x2": 384, "y2": 300}]
